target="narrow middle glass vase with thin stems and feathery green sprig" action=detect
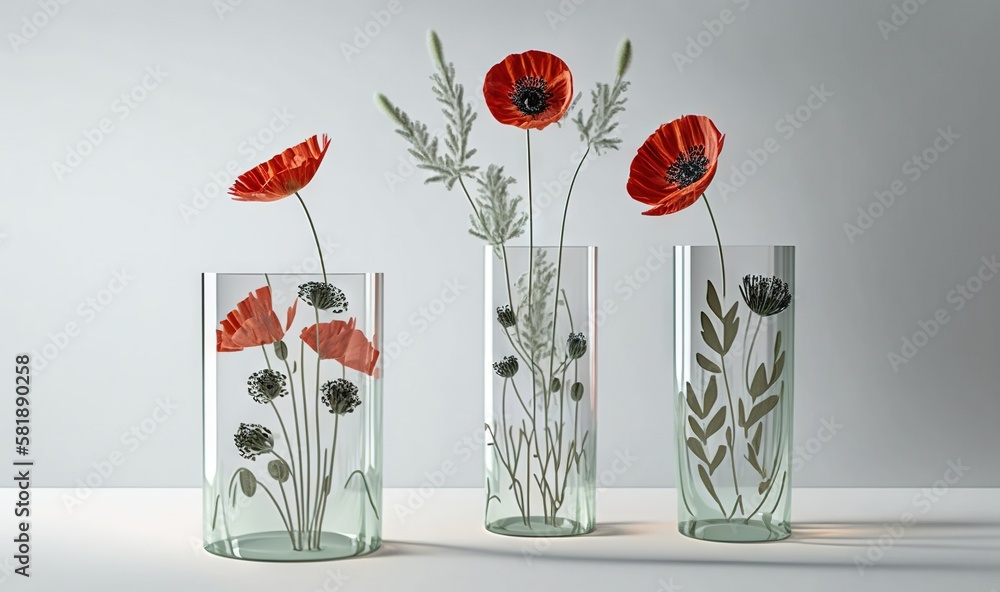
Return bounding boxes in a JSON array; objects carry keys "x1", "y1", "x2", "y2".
[{"x1": 484, "y1": 247, "x2": 597, "y2": 537}]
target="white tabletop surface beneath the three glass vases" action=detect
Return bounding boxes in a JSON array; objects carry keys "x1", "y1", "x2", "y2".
[{"x1": 0, "y1": 489, "x2": 1000, "y2": 592}]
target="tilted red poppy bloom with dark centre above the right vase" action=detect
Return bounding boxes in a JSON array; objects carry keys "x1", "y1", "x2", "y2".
[{"x1": 627, "y1": 115, "x2": 726, "y2": 216}]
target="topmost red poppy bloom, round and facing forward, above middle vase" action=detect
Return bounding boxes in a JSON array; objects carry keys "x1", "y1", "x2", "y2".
[{"x1": 483, "y1": 50, "x2": 573, "y2": 129}]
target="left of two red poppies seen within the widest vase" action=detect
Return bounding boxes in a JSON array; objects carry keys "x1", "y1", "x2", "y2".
[{"x1": 215, "y1": 286, "x2": 299, "y2": 352}]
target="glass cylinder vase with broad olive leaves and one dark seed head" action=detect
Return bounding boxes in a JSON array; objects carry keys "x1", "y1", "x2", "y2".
[{"x1": 674, "y1": 246, "x2": 795, "y2": 543}]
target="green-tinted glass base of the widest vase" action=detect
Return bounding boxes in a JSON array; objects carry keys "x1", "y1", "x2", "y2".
[{"x1": 205, "y1": 531, "x2": 382, "y2": 562}]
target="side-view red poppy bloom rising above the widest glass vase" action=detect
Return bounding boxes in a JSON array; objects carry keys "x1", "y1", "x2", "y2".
[{"x1": 229, "y1": 134, "x2": 330, "y2": 201}]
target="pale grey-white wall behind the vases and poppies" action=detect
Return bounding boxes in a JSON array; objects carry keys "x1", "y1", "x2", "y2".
[{"x1": 0, "y1": 0, "x2": 1000, "y2": 486}]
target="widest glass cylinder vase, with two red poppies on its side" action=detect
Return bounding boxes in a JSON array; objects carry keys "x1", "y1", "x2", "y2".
[{"x1": 202, "y1": 273, "x2": 382, "y2": 561}]
